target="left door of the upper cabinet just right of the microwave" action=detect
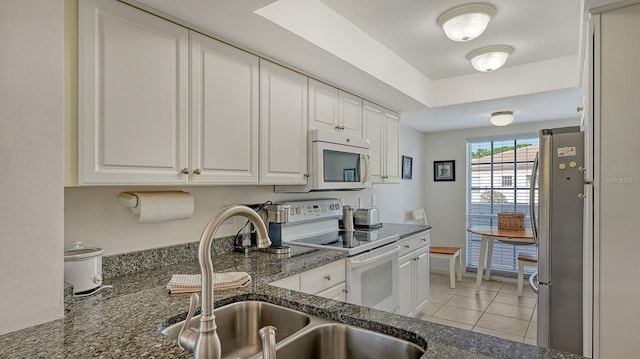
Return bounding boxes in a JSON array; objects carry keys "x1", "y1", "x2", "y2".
[{"x1": 362, "y1": 101, "x2": 384, "y2": 183}]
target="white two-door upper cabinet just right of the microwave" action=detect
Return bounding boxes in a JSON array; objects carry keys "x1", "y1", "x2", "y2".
[{"x1": 362, "y1": 101, "x2": 400, "y2": 183}]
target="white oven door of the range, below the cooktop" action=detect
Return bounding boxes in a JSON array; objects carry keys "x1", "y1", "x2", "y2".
[{"x1": 347, "y1": 244, "x2": 400, "y2": 313}]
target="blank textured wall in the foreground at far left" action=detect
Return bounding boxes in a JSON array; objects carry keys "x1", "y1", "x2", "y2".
[{"x1": 0, "y1": 0, "x2": 64, "y2": 334}]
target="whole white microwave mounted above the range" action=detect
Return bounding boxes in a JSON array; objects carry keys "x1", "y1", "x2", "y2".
[{"x1": 275, "y1": 130, "x2": 371, "y2": 192}]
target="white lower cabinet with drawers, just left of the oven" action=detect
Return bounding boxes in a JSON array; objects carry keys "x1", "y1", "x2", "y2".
[{"x1": 270, "y1": 259, "x2": 346, "y2": 302}]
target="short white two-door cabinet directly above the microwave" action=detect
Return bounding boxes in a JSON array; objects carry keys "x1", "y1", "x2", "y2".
[{"x1": 309, "y1": 79, "x2": 362, "y2": 137}]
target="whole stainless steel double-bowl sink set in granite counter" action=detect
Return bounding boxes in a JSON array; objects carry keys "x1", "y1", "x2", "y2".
[{"x1": 162, "y1": 301, "x2": 424, "y2": 359}]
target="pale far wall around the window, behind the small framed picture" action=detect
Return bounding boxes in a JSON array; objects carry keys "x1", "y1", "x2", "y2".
[{"x1": 424, "y1": 119, "x2": 580, "y2": 271}]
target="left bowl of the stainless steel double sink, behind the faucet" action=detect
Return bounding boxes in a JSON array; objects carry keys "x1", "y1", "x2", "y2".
[{"x1": 162, "y1": 301, "x2": 311, "y2": 358}]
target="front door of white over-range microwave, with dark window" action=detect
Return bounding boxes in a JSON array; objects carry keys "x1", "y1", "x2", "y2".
[{"x1": 312, "y1": 141, "x2": 371, "y2": 190}]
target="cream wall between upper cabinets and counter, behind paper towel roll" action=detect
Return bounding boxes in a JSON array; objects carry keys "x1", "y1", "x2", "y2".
[{"x1": 64, "y1": 126, "x2": 424, "y2": 255}]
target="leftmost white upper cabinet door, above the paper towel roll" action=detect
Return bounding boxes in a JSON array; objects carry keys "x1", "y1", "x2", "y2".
[{"x1": 78, "y1": 0, "x2": 189, "y2": 184}]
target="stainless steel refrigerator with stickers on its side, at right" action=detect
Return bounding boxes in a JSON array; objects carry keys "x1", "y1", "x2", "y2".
[{"x1": 529, "y1": 127, "x2": 589, "y2": 354}]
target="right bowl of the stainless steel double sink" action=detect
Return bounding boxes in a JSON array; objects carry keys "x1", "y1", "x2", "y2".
[{"x1": 276, "y1": 323, "x2": 424, "y2": 359}]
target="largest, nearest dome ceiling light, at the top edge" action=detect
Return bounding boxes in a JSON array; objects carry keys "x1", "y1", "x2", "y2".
[{"x1": 438, "y1": 3, "x2": 496, "y2": 42}]
